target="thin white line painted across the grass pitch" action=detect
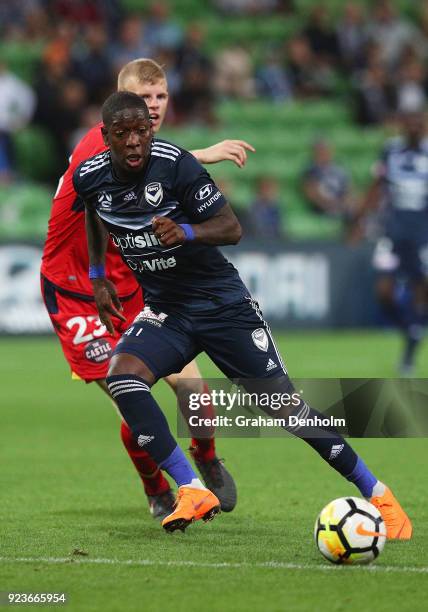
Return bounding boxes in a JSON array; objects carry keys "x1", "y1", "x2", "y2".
[{"x1": 0, "y1": 557, "x2": 428, "y2": 574}]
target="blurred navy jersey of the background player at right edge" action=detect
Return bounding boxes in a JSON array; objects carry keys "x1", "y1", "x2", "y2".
[{"x1": 377, "y1": 138, "x2": 428, "y2": 238}]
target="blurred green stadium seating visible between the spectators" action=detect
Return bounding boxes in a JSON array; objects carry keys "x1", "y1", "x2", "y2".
[{"x1": 0, "y1": 0, "x2": 398, "y2": 240}]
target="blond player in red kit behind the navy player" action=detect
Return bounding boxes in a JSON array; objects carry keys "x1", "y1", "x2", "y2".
[{"x1": 41, "y1": 59, "x2": 254, "y2": 518}]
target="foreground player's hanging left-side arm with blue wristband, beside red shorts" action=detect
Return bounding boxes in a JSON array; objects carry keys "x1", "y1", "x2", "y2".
[{"x1": 85, "y1": 204, "x2": 126, "y2": 336}]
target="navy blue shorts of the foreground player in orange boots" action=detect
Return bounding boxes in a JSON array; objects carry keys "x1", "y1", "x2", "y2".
[{"x1": 114, "y1": 299, "x2": 286, "y2": 379}]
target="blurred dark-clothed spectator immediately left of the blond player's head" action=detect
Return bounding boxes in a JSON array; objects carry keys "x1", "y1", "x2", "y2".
[{"x1": 72, "y1": 25, "x2": 115, "y2": 104}]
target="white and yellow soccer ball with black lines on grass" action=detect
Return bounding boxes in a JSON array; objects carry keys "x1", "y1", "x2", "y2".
[{"x1": 314, "y1": 497, "x2": 386, "y2": 565}]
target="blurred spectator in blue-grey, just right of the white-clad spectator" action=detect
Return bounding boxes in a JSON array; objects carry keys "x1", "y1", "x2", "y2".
[{"x1": 256, "y1": 49, "x2": 293, "y2": 102}]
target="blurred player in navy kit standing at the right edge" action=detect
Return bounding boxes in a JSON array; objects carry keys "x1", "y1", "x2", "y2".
[{"x1": 359, "y1": 112, "x2": 428, "y2": 376}]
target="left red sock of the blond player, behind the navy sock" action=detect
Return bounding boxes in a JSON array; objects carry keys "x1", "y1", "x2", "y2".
[{"x1": 120, "y1": 421, "x2": 170, "y2": 495}]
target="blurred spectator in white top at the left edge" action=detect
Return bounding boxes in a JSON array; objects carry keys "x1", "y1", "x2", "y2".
[{"x1": 0, "y1": 63, "x2": 35, "y2": 183}]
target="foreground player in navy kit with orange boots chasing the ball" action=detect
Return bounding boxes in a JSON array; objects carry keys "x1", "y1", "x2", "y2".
[{"x1": 74, "y1": 92, "x2": 412, "y2": 539}]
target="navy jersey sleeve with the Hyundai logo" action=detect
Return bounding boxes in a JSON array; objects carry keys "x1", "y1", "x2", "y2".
[{"x1": 175, "y1": 153, "x2": 226, "y2": 223}]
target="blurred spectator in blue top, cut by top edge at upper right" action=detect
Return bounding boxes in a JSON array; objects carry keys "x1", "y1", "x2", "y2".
[{"x1": 336, "y1": 2, "x2": 367, "y2": 70}]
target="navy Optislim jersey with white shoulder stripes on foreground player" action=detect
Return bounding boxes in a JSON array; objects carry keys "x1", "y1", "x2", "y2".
[{"x1": 73, "y1": 139, "x2": 248, "y2": 309}]
